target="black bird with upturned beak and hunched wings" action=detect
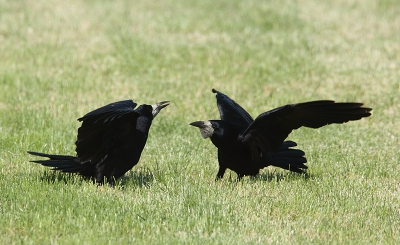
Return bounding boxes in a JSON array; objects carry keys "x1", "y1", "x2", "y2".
[{"x1": 28, "y1": 100, "x2": 169, "y2": 184}]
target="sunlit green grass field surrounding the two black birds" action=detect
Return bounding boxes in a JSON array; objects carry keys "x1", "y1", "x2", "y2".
[{"x1": 0, "y1": 0, "x2": 400, "y2": 244}]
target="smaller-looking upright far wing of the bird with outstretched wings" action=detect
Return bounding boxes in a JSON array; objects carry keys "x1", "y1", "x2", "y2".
[{"x1": 212, "y1": 89, "x2": 253, "y2": 127}]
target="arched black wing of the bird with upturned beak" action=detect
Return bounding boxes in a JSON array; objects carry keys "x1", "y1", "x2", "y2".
[{"x1": 75, "y1": 100, "x2": 140, "y2": 163}]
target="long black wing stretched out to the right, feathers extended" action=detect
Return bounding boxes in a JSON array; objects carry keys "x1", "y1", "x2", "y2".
[{"x1": 242, "y1": 100, "x2": 372, "y2": 156}]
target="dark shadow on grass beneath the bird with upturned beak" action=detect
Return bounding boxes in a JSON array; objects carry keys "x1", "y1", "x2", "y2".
[{"x1": 40, "y1": 169, "x2": 154, "y2": 188}]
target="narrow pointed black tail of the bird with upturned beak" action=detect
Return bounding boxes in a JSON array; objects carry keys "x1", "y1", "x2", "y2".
[{"x1": 28, "y1": 151, "x2": 89, "y2": 174}]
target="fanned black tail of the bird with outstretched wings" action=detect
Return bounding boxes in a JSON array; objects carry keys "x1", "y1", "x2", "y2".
[{"x1": 263, "y1": 141, "x2": 308, "y2": 173}]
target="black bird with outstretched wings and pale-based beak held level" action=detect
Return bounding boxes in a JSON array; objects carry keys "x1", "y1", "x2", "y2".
[{"x1": 190, "y1": 89, "x2": 372, "y2": 179}]
